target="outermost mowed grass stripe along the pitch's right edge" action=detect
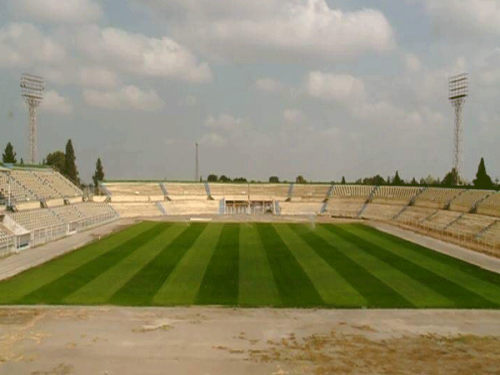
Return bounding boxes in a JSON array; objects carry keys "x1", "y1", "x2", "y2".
[{"x1": 345, "y1": 225, "x2": 500, "y2": 305}]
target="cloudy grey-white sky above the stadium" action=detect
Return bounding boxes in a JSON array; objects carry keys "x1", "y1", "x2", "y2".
[{"x1": 0, "y1": 0, "x2": 500, "y2": 181}]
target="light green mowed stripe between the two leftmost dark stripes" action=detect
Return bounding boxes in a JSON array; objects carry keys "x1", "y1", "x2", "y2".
[{"x1": 64, "y1": 223, "x2": 186, "y2": 305}]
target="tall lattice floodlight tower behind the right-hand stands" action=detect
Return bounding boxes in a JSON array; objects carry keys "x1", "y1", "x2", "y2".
[{"x1": 448, "y1": 73, "x2": 469, "y2": 184}]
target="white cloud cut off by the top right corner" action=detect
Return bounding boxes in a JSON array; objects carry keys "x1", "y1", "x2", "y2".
[{"x1": 425, "y1": 0, "x2": 500, "y2": 35}]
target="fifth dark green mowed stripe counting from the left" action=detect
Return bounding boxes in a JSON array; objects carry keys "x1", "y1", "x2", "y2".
[{"x1": 290, "y1": 224, "x2": 414, "y2": 308}]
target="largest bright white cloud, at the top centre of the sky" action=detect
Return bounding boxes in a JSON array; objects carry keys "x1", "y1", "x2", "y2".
[{"x1": 143, "y1": 0, "x2": 395, "y2": 61}]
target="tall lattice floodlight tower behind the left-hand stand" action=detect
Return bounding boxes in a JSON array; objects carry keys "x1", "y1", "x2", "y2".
[{"x1": 21, "y1": 73, "x2": 45, "y2": 164}]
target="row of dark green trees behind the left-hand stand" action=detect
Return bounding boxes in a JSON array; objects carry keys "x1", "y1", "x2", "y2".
[{"x1": 2, "y1": 139, "x2": 104, "y2": 192}]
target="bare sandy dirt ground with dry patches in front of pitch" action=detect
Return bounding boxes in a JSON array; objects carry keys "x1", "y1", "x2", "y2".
[{"x1": 0, "y1": 307, "x2": 500, "y2": 375}]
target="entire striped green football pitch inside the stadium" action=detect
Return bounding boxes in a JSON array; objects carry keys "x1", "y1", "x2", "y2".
[{"x1": 0, "y1": 222, "x2": 500, "y2": 308}]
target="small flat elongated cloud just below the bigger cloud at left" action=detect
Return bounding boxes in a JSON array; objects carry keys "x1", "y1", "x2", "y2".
[{"x1": 83, "y1": 86, "x2": 165, "y2": 111}]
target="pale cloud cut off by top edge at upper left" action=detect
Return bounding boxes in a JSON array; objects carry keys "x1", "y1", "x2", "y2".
[{"x1": 10, "y1": 0, "x2": 102, "y2": 24}]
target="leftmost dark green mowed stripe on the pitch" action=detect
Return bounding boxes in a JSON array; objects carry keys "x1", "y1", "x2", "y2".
[{"x1": 18, "y1": 223, "x2": 170, "y2": 304}]
